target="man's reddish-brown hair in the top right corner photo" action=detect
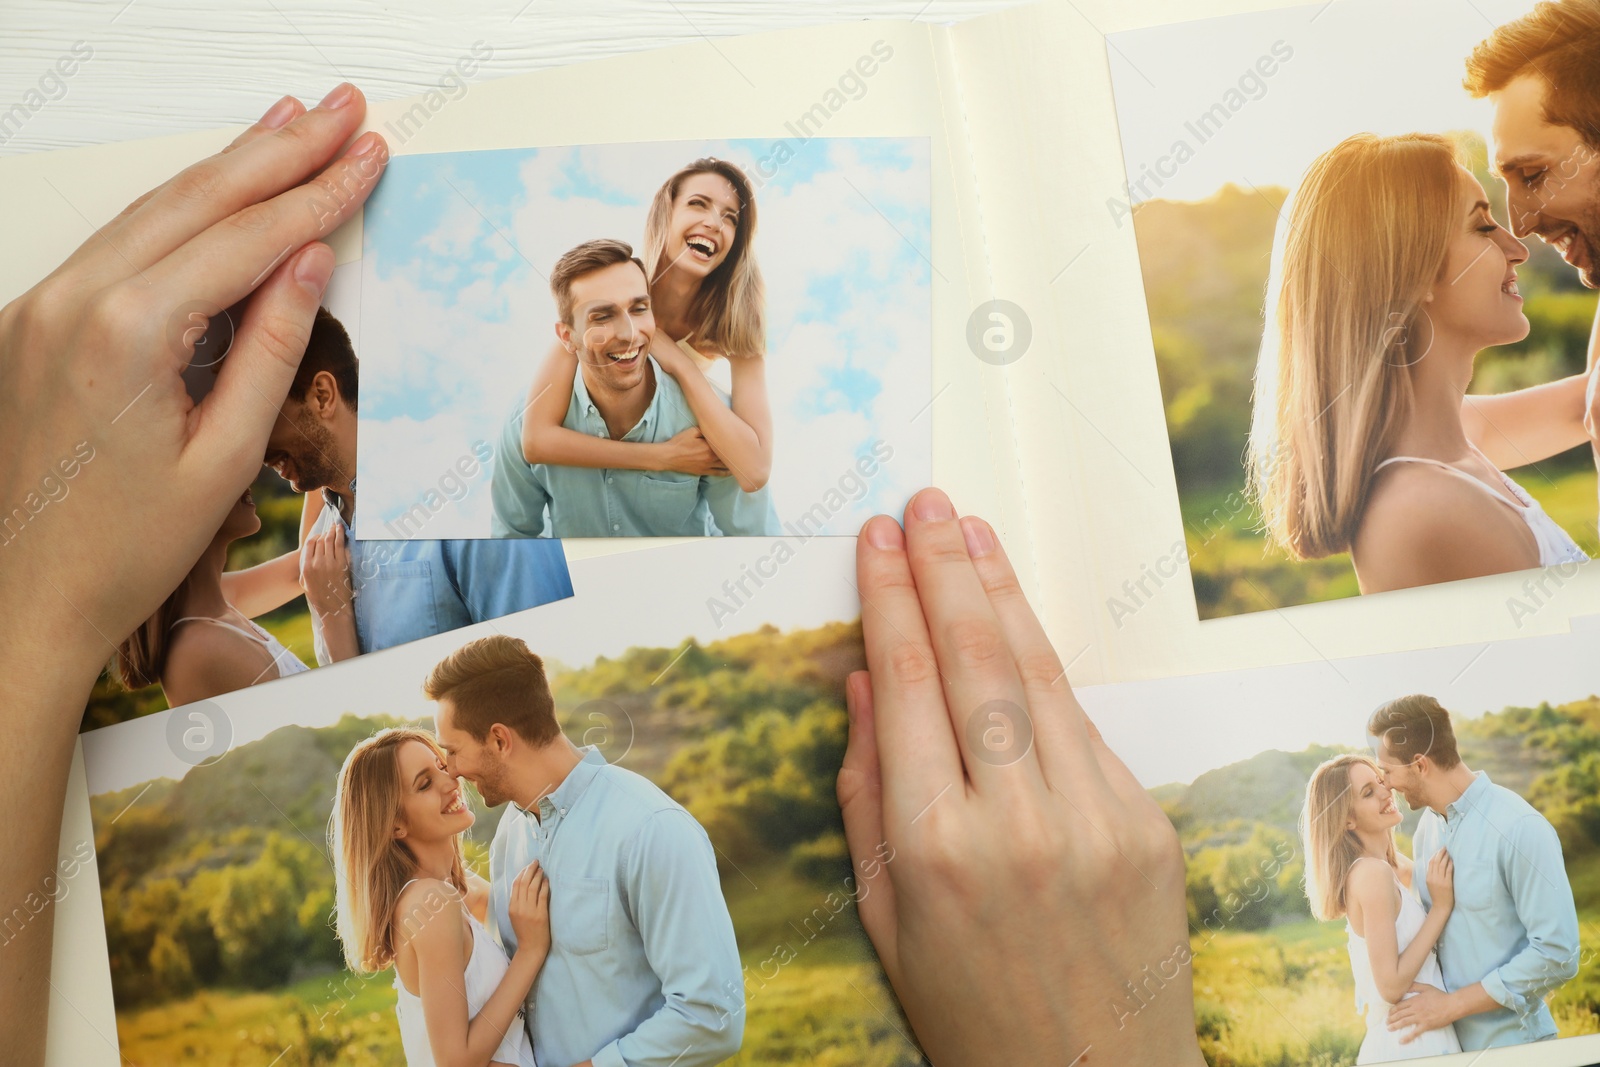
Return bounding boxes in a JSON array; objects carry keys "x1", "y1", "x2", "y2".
[{"x1": 1466, "y1": 0, "x2": 1600, "y2": 150}]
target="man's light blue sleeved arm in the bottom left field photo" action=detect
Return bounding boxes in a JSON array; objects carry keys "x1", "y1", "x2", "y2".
[{"x1": 590, "y1": 808, "x2": 744, "y2": 1067}]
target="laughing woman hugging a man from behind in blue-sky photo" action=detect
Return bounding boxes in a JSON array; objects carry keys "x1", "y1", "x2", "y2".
[{"x1": 522, "y1": 158, "x2": 773, "y2": 493}]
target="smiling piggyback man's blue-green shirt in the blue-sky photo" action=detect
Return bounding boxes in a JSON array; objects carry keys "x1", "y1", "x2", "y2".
[{"x1": 490, "y1": 357, "x2": 782, "y2": 537}]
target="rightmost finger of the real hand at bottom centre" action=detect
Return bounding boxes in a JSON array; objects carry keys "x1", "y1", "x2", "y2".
[{"x1": 960, "y1": 517, "x2": 1107, "y2": 792}]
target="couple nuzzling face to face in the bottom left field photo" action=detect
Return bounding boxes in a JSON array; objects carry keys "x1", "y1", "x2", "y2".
[{"x1": 330, "y1": 635, "x2": 744, "y2": 1067}]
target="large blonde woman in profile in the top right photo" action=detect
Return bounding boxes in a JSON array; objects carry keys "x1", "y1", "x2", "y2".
[{"x1": 1250, "y1": 134, "x2": 1589, "y2": 593}]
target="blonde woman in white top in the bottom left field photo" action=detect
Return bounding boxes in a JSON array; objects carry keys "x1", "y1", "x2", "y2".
[{"x1": 328, "y1": 729, "x2": 550, "y2": 1067}]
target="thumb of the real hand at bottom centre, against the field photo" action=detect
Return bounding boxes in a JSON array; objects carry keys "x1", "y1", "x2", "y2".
[{"x1": 837, "y1": 670, "x2": 899, "y2": 981}]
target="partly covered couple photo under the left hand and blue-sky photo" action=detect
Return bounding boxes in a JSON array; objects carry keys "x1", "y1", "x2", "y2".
[{"x1": 80, "y1": 264, "x2": 573, "y2": 729}]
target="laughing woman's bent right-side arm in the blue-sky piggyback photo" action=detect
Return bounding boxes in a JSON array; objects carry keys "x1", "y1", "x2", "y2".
[{"x1": 650, "y1": 333, "x2": 773, "y2": 493}]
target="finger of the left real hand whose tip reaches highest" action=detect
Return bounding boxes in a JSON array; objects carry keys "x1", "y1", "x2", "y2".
[{"x1": 109, "y1": 83, "x2": 366, "y2": 273}]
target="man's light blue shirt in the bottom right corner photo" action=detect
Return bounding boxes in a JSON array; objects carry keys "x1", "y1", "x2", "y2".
[{"x1": 1411, "y1": 771, "x2": 1578, "y2": 1051}]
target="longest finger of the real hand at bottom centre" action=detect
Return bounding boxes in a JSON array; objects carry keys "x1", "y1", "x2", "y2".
[{"x1": 906, "y1": 490, "x2": 1043, "y2": 792}]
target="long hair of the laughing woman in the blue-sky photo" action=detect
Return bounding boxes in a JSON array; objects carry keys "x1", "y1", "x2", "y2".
[{"x1": 643, "y1": 157, "x2": 766, "y2": 358}]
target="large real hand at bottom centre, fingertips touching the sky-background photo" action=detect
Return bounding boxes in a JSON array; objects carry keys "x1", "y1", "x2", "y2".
[{"x1": 838, "y1": 490, "x2": 1202, "y2": 1067}]
